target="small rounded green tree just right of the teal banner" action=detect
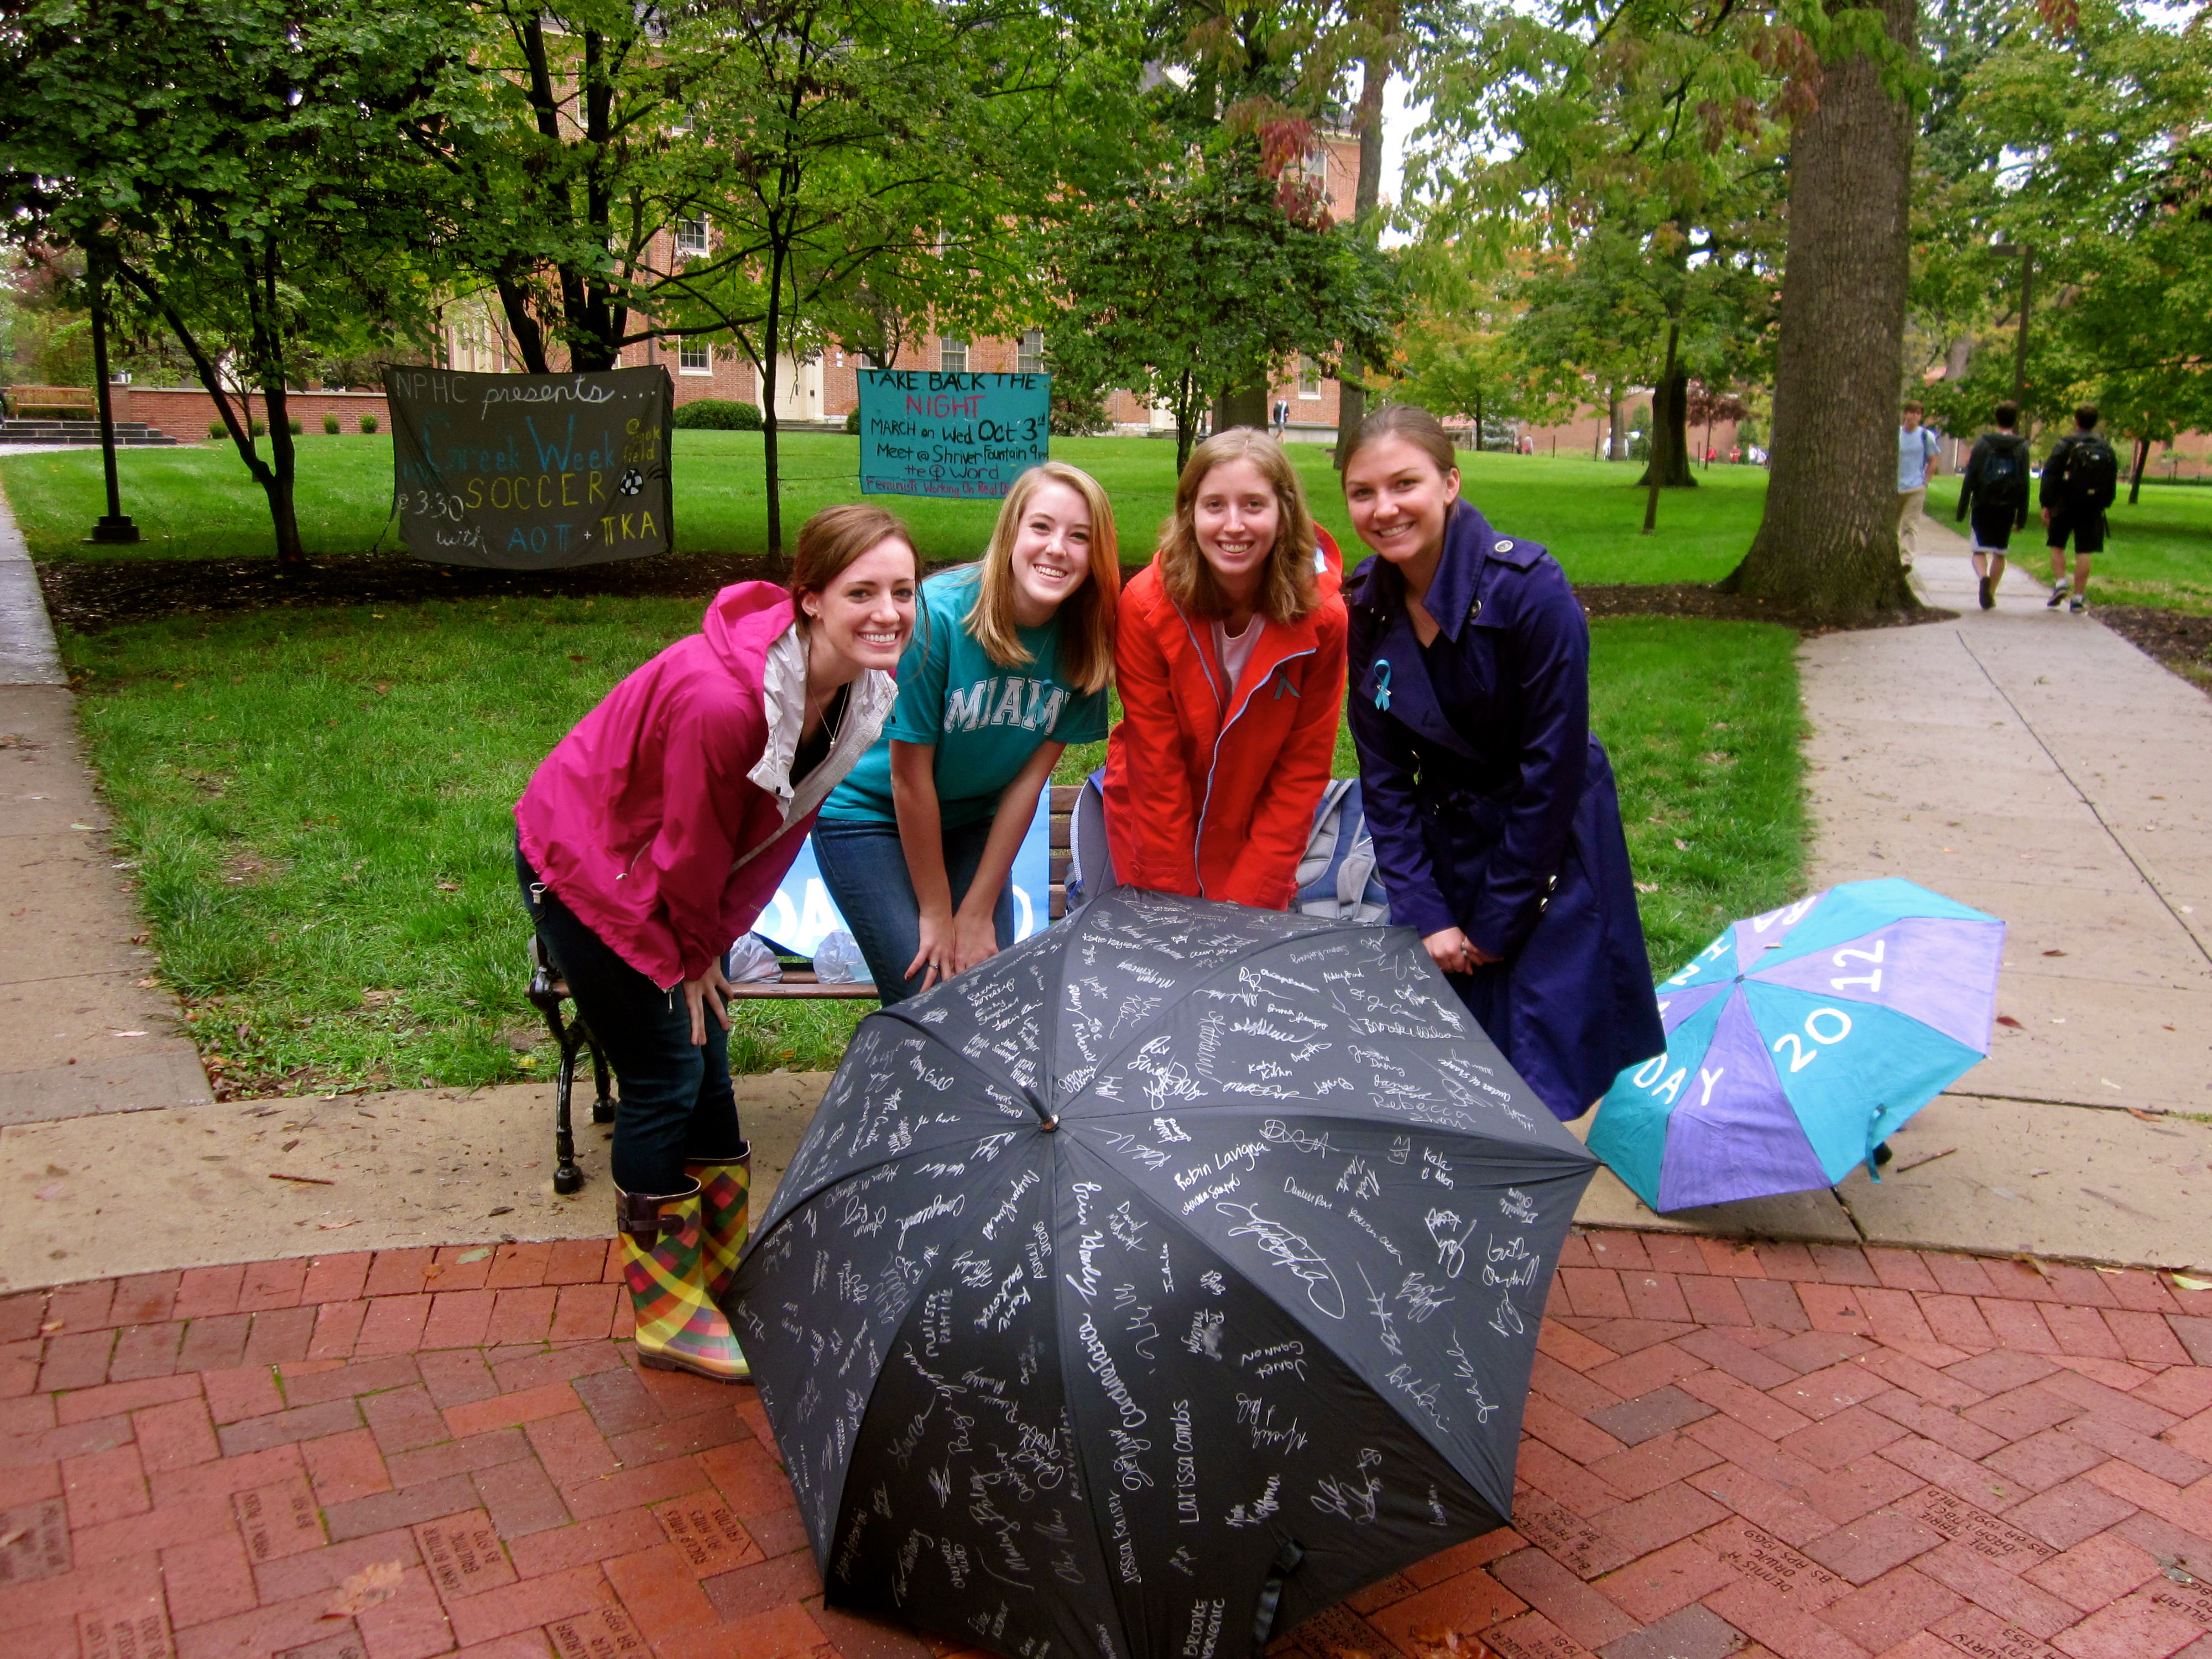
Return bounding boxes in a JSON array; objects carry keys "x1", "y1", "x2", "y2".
[{"x1": 1048, "y1": 144, "x2": 1402, "y2": 469}]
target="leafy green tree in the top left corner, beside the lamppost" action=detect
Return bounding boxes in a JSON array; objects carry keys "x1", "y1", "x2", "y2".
[{"x1": 0, "y1": 0, "x2": 445, "y2": 564}]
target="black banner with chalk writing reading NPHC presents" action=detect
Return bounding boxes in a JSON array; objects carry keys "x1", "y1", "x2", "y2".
[{"x1": 385, "y1": 369, "x2": 675, "y2": 571}]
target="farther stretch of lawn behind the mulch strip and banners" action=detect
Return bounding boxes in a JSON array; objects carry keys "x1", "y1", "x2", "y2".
[{"x1": 0, "y1": 431, "x2": 1767, "y2": 582}]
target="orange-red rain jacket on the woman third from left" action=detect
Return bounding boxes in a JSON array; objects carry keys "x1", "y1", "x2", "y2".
[{"x1": 1106, "y1": 531, "x2": 1347, "y2": 909}]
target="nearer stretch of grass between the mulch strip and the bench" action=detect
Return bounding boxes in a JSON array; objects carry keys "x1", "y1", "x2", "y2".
[{"x1": 69, "y1": 606, "x2": 1805, "y2": 1093}]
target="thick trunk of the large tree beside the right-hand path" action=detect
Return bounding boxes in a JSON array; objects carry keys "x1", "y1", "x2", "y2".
[{"x1": 1721, "y1": 0, "x2": 1918, "y2": 619}]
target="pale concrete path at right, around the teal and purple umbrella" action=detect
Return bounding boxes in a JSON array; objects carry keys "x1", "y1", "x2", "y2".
[{"x1": 1582, "y1": 520, "x2": 2212, "y2": 1270}]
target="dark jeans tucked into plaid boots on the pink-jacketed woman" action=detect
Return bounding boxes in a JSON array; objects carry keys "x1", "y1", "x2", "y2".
[{"x1": 515, "y1": 847, "x2": 745, "y2": 1197}]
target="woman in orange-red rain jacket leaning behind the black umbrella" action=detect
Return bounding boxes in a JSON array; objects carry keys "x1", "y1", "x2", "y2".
[{"x1": 1106, "y1": 427, "x2": 1345, "y2": 909}]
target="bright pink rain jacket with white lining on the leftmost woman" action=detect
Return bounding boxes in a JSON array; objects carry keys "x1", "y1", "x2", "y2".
[{"x1": 515, "y1": 582, "x2": 896, "y2": 989}]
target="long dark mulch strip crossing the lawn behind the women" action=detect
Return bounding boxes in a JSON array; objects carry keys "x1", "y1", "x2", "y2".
[{"x1": 38, "y1": 553, "x2": 1964, "y2": 650}]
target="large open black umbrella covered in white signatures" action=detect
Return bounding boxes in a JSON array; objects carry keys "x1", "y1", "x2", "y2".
[{"x1": 734, "y1": 889, "x2": 1595, "y2": 1659}]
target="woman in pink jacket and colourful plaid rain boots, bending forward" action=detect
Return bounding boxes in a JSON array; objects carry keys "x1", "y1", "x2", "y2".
[{"x1": 515, "y1": 507, "x2": 914, "y2": 1380}]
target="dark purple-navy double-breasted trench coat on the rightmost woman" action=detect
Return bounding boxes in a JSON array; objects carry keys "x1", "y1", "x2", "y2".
[{"x1": 1345, "y1": 502, "x2": 1666, "y2": 1119}]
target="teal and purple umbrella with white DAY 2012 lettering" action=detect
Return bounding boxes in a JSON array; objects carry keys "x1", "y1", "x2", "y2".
[{"x1": 1590, "y1": 878, "x2": 2004, "y2": 1210}]
